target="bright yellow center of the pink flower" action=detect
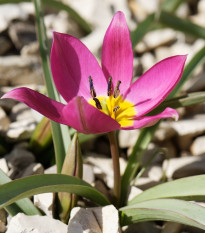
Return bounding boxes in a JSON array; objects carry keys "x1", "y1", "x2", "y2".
[{"x1": 88, "y1": 95, "x2": 137, "y2": 127}]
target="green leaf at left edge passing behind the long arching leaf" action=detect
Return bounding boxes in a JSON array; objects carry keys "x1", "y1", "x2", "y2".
[{"x1": 0, "y1": 169, "x2": 41, "y2": 216}]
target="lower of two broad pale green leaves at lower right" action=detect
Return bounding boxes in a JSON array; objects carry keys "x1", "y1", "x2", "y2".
[{"x1": 120, "y1": 199, "x2": 205, "y2": 230}]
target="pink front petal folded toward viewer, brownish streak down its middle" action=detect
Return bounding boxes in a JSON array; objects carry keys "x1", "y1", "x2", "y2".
[{"x1": 63, "y1": 96, "x2": 120, "y2": 134}]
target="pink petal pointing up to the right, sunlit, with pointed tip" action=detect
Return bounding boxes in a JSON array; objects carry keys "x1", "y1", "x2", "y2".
[{"x1": 125, "y1": 55, "x2": 187, "y2": 116}]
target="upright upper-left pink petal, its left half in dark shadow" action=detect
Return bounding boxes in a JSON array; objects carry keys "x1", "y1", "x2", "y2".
[{"x1": 51, "y1": 32, "x2": 107, "y2": 102}]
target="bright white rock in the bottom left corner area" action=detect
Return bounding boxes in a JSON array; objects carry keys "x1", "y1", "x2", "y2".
[{"x1": 6, "y1": 213, "x2": 67, "y2": 233}]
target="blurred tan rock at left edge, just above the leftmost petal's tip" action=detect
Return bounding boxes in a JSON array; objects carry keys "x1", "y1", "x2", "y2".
[{"x1": 0, "y1": 55, "x2": 43, "y2": 86}]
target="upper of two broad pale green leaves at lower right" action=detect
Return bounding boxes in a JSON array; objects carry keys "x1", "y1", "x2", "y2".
[{"x1": 129, "y1": 175, "x2": 205, "y2": 205}]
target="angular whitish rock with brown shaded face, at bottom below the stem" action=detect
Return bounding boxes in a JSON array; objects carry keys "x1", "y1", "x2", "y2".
[{"x1": 68, "y1": 205, "x2": 121, "y2": 233}]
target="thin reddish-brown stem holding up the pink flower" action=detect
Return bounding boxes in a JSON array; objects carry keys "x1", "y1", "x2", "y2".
[{"x1": 108, "y1": 131, "x2": 121, "y2": 207}]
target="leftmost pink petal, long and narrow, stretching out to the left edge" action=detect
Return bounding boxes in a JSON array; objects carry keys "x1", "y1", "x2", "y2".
[{"x1": 1, "y1": 87, "x2": 65, "y2": 124}]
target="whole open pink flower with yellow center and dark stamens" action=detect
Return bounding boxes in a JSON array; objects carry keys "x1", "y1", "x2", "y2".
[{"x1": 2, "y1": 12, "x2": 186, "y2": 134}]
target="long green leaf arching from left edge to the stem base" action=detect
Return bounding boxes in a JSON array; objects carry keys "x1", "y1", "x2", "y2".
[{"x1": 0, "y1": 174, "x2": 110, "y2": 208}]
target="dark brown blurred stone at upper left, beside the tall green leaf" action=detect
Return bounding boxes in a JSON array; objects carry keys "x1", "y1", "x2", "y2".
[{"x1": 8, "y1": 22, "x2": 36, "y2": 50}]
